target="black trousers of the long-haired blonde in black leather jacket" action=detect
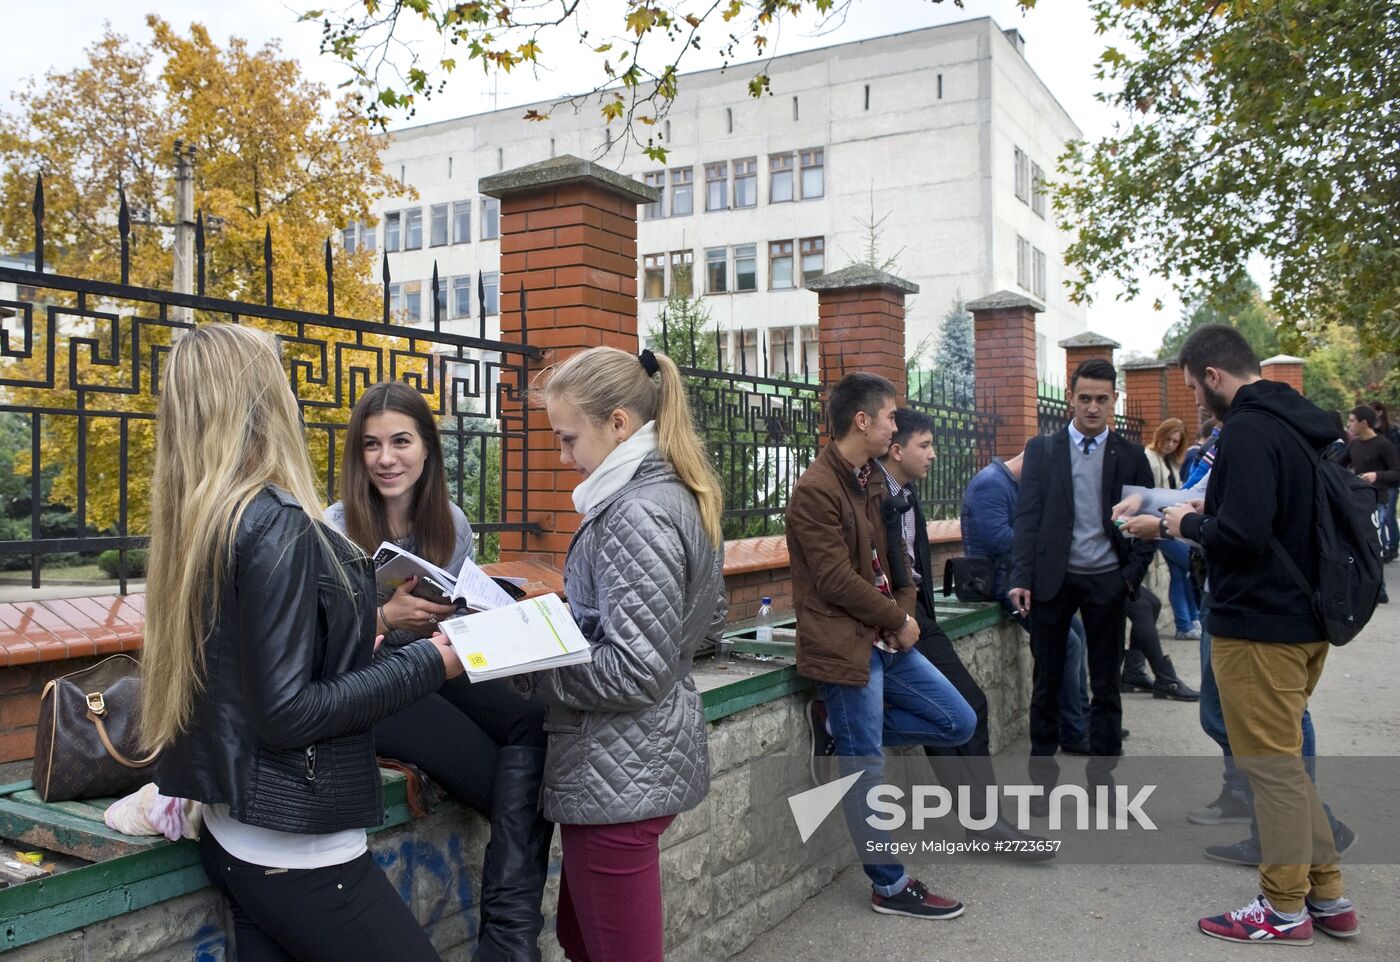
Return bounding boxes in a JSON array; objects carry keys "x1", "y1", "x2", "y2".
[{"x1": 199, "y1": 829, "x2": 440, "y2": 962}]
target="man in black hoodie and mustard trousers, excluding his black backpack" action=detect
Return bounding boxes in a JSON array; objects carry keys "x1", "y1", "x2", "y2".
[{"x1": 1162, "y1": 325, "x2": 1358, "y2": 944}]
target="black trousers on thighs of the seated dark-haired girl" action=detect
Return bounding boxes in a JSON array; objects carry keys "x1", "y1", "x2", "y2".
[{"x1": 374, "y1": 675, "x2": 546, "y2": 818}]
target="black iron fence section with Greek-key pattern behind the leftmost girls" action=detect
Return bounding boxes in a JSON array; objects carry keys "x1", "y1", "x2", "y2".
[{"x1": 0, "y1": 181, "x2": 542, "y2": 592}]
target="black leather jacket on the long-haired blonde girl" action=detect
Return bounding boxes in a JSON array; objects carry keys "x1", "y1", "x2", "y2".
[{"x1": 156, "y1": 487, "x2": 444, "y2": 835}]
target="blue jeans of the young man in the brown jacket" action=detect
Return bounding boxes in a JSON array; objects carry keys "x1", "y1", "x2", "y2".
[{"x1": 822, "y1": 647, "x2": 977, "y2": 895}]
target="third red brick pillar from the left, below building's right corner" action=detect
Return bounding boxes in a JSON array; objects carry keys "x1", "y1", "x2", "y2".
[{"x1": 967, "y1": 291, "x2": 1044, "y2": 458}]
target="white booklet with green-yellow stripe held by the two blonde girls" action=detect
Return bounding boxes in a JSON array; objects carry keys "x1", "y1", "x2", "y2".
[{"x1": 438, "y1": 594, "x2": 594, "y2": 682}]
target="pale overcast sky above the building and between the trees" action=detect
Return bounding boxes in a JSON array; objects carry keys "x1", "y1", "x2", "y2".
[{"x1": 0, "y1": 0, "x2": 1204, "y2": 353}]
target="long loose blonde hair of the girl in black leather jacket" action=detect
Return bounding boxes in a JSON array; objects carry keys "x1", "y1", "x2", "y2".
[{"x1": 141, "y1": 323, "x2": 341, "y2": 749}]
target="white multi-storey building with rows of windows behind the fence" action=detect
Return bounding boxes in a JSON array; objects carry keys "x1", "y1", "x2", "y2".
[{"x1": 355, "y1": 18, "x2": 1085, "y2": 374}]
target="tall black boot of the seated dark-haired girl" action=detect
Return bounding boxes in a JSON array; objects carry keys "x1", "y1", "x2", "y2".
[{"x1": 472, "y1": 745, "x2": 554, "y2": 962}]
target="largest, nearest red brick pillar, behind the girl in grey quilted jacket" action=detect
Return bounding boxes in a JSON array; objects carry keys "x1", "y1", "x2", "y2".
[{"x1": 479, "y1": 155, "x2": 658, "y2": 567}]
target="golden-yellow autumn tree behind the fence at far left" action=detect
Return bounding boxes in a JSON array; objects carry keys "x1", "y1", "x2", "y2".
[{"x1": 0, "y1": 17, "x2": 406, "y2": 531}]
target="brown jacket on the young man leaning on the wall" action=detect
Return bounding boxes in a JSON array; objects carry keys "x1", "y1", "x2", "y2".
[{"x1": 787, "y1": 444, "x2": 914, "y2": 685}]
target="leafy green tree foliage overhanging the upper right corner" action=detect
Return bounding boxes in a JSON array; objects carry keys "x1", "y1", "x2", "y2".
[{"x1": 1053, "y1": 0, "x2": 1400, "y2": 350}]
